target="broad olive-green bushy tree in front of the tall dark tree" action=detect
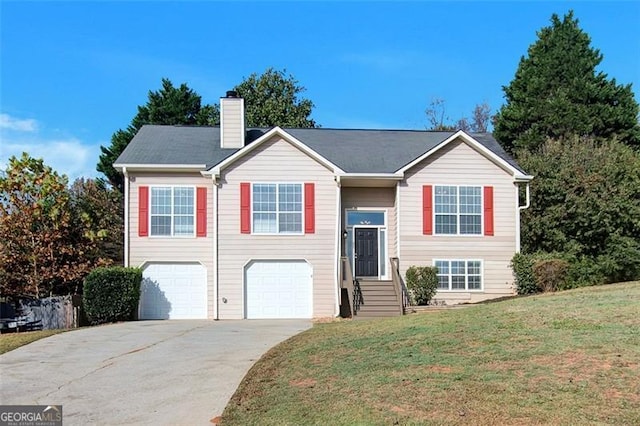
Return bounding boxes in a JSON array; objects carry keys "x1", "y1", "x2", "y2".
[{"x1": 518, "y1": 136, "x2": 640, "y2": 281}]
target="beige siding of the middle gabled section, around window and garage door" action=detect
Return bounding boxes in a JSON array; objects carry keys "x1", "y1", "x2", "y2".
[{"x1": 218, "y1": 137, "x2": 337, "y2": 319}]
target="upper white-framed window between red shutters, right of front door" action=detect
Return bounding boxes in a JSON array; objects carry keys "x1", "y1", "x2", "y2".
[{"x1": 435, "y1": 185, "x2": 482, "y2": 235}]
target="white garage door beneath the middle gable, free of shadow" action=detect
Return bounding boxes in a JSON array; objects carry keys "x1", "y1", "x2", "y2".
[{"x1": 245, "y1": 260, "x2": 312, "y2": 319}]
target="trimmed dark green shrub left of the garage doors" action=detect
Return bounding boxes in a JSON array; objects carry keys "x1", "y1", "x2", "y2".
[{"x1": 82, "y1": 266, "x2": 142, "y2": 324}]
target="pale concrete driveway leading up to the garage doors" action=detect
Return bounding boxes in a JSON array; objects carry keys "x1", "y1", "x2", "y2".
[{"x1": 0, "y1": 320, "x2": 311, "y2": 425}]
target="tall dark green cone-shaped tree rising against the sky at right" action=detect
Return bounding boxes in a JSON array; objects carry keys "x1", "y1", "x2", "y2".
[{"x1": 494, "y1": 12, "x2": 640, "y2": 153}]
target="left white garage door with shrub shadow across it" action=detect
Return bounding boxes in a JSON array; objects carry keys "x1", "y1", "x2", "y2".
[{"x1": 140, "y1": 263, "x2": 207, "y2": 319}]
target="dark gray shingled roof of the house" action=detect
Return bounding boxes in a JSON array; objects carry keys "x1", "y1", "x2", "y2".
[{"x1": 116, "y1": 125, "x2": 524, "y2": 173}]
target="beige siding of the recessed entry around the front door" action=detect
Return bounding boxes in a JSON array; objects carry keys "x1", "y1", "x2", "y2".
[{"x1": 341, "y1": 187, "x2": 397, "y2": 262}]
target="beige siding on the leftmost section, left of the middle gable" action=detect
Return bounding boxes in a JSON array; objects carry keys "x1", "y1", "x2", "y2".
[{"x1": 129, "y1": 173, "x2": 214, "y2": 318}]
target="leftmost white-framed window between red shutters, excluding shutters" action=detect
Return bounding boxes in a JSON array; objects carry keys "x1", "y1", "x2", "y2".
[{"x1": 151, "y1": 186, "x2": 195, "y2": 236}]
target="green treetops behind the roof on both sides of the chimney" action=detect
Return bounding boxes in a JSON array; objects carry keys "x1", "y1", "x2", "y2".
[{"x1": 96, "y1": 68, "x2": 317, "y2": 192}]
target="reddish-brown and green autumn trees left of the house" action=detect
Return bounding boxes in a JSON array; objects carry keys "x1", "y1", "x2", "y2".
[{"x1": 0, "y1": 153, "x2": 123, "y2": 299}]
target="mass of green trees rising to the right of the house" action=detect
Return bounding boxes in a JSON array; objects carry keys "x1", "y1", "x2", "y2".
[{"x1": 494, "y1": 12, "x2": 640, "y2": 292}]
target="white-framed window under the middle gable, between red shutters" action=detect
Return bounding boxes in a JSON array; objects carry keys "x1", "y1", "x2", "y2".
[{"x1": 252, "y1": 183, "x2": 302, "y2": 234}]
